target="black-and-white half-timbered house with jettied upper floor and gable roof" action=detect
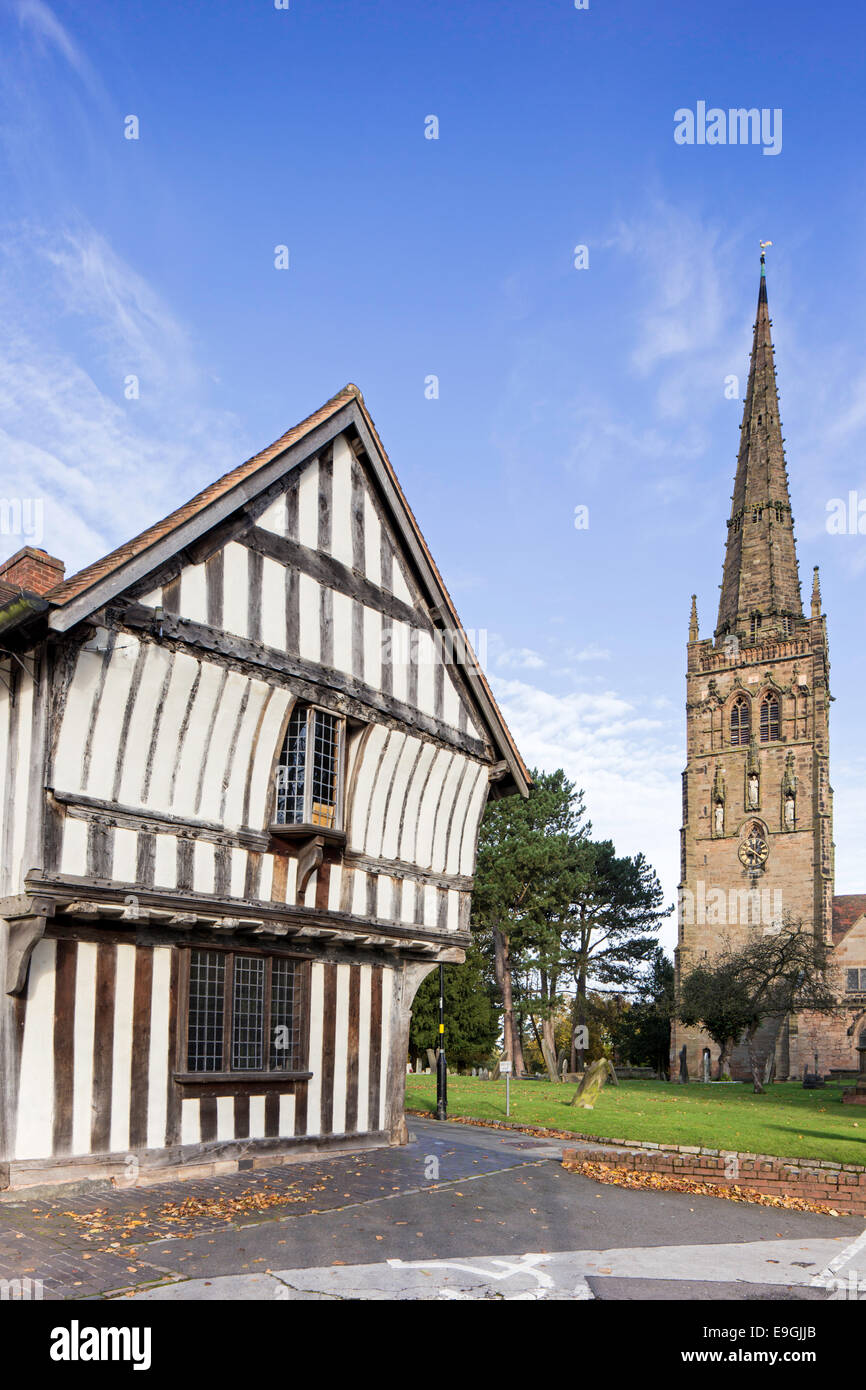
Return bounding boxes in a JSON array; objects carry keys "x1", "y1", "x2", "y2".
[{"x1": 0, "y1": 385, "x2": 528, "y2": 1187}]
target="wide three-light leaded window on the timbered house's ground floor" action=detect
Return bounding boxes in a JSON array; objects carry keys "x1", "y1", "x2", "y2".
[{"x1": 186, "y1": 949, "x2": 304, "y2": 1074}]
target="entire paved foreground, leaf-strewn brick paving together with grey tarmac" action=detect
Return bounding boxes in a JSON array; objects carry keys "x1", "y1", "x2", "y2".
[{"x1": 0, "y1": 1118, "x2": 866, "y2": 1300}]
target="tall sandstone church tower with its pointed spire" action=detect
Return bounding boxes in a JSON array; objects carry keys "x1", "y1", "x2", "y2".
[{"x1": 671, "y1": 254, "x2": 833, "y2": 1077}]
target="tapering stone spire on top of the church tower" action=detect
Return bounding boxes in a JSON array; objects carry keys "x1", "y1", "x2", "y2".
[{"x1": 716, "y1": 252, "x2": 803, "y2": 642}]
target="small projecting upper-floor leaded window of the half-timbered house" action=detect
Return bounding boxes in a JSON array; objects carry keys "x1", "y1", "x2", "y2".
[{"x1": 275, "y1": 705, "x2": 345, "y2": 830}]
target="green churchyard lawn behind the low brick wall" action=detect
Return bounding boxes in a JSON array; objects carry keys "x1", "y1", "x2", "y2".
[{"x1": 406, "y1": 1074, "x2": 866, "y2": 1163}]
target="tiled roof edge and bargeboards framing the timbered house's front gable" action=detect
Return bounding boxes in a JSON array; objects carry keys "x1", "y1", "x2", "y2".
[{"x1": 11, "y1": 382, "x2": 530, "y2": 796}]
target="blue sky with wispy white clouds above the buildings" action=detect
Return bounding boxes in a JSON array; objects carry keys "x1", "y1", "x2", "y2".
[{"x1": 0, "y1": 0, "x2": 866, "y2": 944}]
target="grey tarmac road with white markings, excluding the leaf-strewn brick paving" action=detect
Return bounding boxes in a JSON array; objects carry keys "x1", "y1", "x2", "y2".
[{"x1": 103, "y1": 1118, "x2": 866, "y2": 1301}]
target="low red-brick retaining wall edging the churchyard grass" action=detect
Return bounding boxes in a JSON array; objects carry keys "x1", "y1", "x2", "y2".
[{"x1": 563, "y1": 1143, "x2": 866, "y2": 1216}]
